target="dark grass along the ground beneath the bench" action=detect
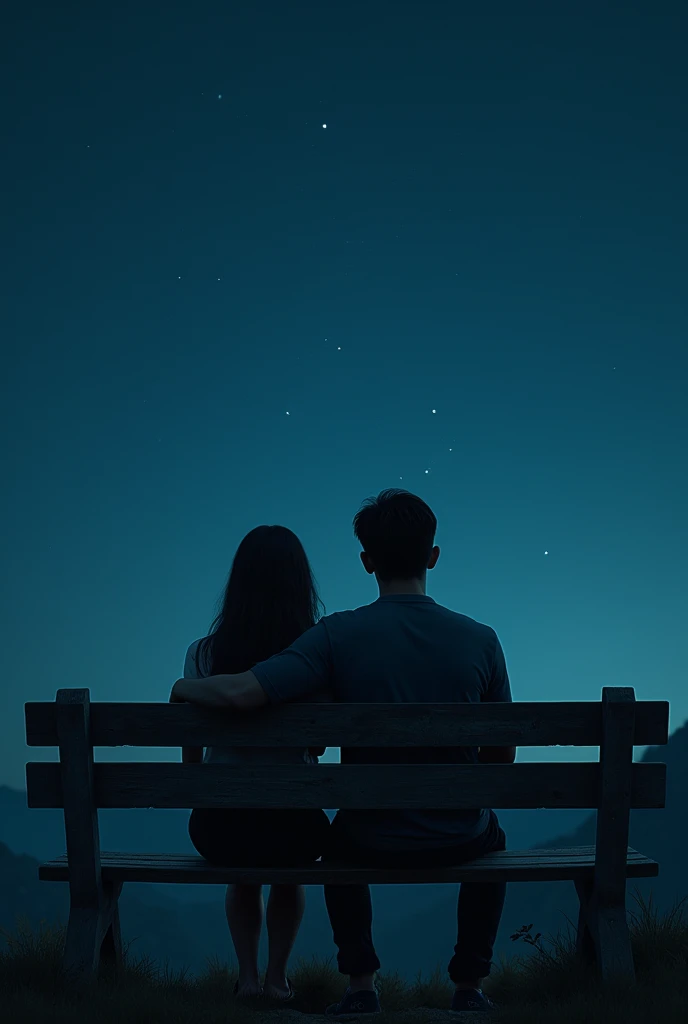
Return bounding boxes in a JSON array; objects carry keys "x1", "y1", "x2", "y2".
[{"x1": 0, "y1": 893, "x2": 688, "y2": 1024}]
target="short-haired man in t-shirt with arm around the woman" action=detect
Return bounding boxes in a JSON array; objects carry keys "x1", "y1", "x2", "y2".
[{"x1": 171, "y1": 488, "x2": 516, "y2": 1016}]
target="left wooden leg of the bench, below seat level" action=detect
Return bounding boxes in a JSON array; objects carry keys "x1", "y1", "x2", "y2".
[{"x1": 62, "y1": 882, "x2": 122, "y2": 987}]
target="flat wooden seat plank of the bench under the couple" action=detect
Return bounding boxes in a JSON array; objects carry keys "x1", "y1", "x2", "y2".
[{"x1": 38, "y1": 846, "x2": 659, "y2": 885}]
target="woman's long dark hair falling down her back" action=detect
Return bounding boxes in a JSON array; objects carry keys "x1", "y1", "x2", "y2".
[{"x1": 196, "y1": 526, "x2": 325, "y2": 675}]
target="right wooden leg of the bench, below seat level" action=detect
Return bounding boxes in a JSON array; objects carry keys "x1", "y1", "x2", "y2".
[{"x1": 575, "y1": 880, "x2": 636, "y2": 981}]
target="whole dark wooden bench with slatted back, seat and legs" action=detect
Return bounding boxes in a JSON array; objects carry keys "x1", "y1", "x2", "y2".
[{"x1": 26, "y1": 687, "x2": 669, "y2": 983}]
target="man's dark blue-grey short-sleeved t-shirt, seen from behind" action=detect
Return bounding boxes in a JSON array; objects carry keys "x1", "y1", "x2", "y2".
[{"x1": 251, "y1": 594, "x2": 512, "y2": 850}]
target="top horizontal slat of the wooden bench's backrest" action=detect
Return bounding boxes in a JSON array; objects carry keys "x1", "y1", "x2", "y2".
[{"x1": 25, "y1": 700, "x2": 669, "y2": 746}]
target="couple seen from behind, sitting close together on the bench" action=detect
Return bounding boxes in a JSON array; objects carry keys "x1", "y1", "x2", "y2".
[{"x1": 170, "y1": 489, "x2": 516, "y2": 1017}]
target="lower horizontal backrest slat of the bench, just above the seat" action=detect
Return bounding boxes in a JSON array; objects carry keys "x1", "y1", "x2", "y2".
[{"x1": 27, "y1": 762, "x2": 667, "y2": 809}]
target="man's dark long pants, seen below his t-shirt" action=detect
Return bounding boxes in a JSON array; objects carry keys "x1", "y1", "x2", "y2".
[{"x1": 323, "y1": 810, "x2": 507, "y2": 984}]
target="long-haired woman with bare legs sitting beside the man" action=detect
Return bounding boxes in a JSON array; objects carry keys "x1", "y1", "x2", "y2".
[{"x1": 182, "y1": 526, "x2": 330, "y2": 999}]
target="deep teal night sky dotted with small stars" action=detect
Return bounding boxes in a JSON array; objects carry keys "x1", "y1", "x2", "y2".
[{"x1": 0, "y1": 0, "x2": 688, "y2": 786}]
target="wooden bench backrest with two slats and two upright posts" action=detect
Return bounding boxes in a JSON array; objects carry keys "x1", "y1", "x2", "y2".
[{"x1": 26, "y1": 687, "x2": 669, "y2": 897}]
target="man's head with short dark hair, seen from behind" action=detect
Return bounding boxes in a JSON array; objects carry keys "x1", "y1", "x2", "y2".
[{"x1": 353, "y1": 487, "x2": 439, "y2": 592}]
